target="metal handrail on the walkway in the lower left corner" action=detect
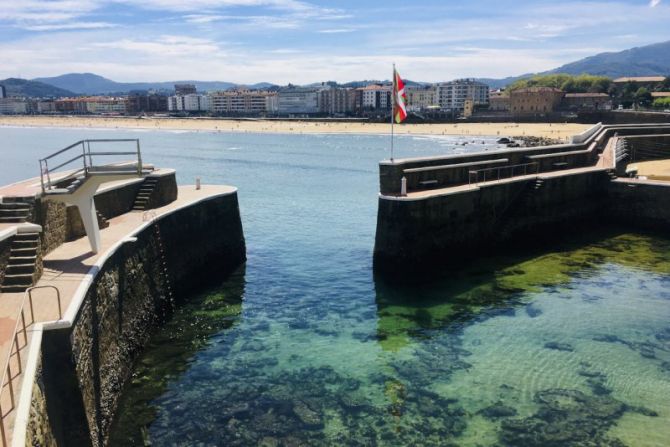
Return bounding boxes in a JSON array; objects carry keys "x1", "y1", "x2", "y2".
[{"x1": 0, "y1": 286, "x2": 63, "y2": 446}]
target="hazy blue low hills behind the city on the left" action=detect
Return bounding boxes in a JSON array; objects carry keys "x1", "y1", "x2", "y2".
[{"x1": 34, "y1": 73, "x2": 272, "y2": 95}]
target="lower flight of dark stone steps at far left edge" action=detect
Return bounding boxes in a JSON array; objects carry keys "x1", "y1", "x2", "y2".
[{"x1": 0, "y1": 233, "x2": 40, "y2": 293}]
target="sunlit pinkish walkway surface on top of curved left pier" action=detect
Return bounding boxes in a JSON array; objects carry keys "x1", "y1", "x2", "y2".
[{"x1": 0, "y1": 185, "x2": 236, "y2": 439}]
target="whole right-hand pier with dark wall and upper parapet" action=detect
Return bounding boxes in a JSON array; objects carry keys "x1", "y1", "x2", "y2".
[{"x1": 374, "y1": 124, "x2": 670, "y2": 277}]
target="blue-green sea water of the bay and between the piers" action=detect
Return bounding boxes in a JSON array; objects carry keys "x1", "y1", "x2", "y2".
[{"x1": 0, "y1": 128, "x2": 670, "y2": 446}]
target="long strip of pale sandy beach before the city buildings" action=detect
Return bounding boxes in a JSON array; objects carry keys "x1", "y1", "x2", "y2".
[{"x1": 0, "y1": 116, "x2": 590, "y2": 139}]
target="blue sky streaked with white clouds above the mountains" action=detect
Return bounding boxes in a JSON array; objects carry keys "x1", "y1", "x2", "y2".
[{"x1": 0, "y1": 0, "x2": 670, "y2": 84}]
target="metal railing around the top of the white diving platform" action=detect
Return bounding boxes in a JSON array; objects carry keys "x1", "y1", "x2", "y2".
[{"x1": 40, "y1": 139, "x2": 142, "y2": 192}]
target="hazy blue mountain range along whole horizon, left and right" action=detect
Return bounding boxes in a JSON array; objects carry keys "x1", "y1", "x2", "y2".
[{"x1": 5, "y1": 41, "x2": 670, "y2": 97}]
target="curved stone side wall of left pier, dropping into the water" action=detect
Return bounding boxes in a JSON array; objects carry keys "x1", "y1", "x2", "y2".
[{"x1": 26, "y1": 192, "x2": 246, "y2": 446}]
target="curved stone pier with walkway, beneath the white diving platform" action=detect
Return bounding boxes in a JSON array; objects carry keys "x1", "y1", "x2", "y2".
[{"x1": 0, "y1": 160, "x2": 246, "y2": 446}]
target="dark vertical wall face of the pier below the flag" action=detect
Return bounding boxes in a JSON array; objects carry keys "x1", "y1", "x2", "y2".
[{"x1": 374, "y1": 171, "x2": 610, "y2": 272}]
